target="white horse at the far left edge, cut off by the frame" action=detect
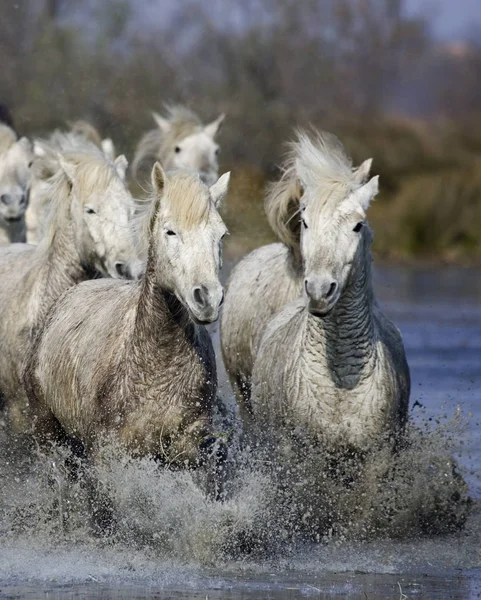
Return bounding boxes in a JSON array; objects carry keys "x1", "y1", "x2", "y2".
[{"x1": 0, "y1": 123, "x2": 34, "y2": 244}]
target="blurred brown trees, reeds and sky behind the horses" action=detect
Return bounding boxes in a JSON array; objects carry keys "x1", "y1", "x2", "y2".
[{"x1": 0, "y1": 0, "x2": 481, "y2": 264}]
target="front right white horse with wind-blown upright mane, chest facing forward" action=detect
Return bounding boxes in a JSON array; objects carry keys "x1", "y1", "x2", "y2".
[{"x1": 250, "y1": 134, "x2": 410, "y2": 449}]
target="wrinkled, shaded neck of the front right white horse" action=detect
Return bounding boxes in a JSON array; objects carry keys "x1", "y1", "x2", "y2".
[{"x1": 308, "y1": 232, "x2": 376, "y2": 388}]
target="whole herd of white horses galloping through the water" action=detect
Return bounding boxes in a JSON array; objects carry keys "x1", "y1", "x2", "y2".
[{"x1": 0, "y1": 107, "x2": 410, "y2": 506}]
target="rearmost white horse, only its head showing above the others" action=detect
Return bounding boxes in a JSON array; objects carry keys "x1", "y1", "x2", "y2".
[{"x1": 132, "y1": 106, "x2": 225, "y2": 185}]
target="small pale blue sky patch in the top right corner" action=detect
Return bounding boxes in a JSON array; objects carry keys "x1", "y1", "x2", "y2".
[{"x1": 406, "y1": 0, "x2": 481, "y2": 41}]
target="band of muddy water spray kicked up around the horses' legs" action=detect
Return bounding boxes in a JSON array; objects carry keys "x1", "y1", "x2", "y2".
[{"x1": 0, "y1": 406, "x2": 472, "y2": 566}]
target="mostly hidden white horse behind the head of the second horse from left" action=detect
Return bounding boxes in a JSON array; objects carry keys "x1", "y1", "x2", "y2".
[{"x1": 25, "y1": 121, "x2": 120, "y2": 244}]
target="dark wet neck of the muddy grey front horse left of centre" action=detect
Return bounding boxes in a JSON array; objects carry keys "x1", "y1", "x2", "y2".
[{"x1": 133, "y1": 249, "x2": 195, "y2": 357}]
